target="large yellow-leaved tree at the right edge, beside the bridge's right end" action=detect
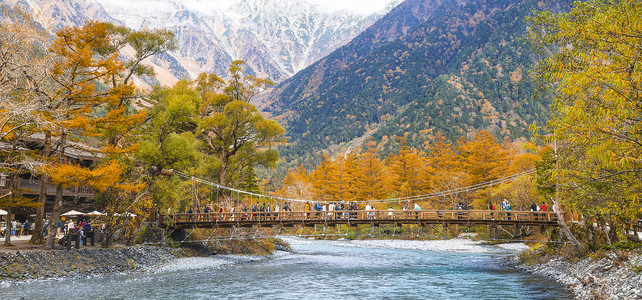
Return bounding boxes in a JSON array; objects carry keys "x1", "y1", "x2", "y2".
[{"x1": 529, "y1": 0, "x2": 642, "y2": 245}]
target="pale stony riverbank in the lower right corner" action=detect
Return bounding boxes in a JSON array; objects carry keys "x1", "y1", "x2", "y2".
[{"x1": 516, "y1": 252, "x2": 642, "y2": 299}]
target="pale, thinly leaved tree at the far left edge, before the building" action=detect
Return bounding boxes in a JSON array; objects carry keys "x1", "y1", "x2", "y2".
[{"x1": 0, "y1": 9, "x2": 52, "y2": 245}]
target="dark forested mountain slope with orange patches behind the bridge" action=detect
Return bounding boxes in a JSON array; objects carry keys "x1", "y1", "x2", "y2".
[{"x1": 261, "y1": 0, "x2": 570, "y2": 163}]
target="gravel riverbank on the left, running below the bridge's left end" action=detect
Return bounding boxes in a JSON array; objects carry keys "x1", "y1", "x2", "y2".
[{"x1": 0, "y1": 232, "x2": 291, "y2": 283}]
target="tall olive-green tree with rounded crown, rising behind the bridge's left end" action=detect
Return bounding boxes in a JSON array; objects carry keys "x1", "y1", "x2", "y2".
[{"x1": 196, "y1": 61, "x2": 285, "y2": 203}]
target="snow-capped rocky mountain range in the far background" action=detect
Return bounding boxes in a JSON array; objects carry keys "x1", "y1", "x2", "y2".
[{"x1": 8, "y1": 0, "x2": 401, "y2": 84}]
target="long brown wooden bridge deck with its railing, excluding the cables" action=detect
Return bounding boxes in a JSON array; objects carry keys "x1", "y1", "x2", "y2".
[{"x1": 160, "y1": 210, "x2": 557, "y2": 228}]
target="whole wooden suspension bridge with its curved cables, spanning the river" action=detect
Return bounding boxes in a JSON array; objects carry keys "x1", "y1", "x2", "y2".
[{"x1": 159, "y1": 169, "x2": 558, "y2": 229}]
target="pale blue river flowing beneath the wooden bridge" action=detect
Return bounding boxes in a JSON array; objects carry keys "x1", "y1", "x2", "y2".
[{"x1": 0, "y1": 238, "x2": 571, "y2": 300}]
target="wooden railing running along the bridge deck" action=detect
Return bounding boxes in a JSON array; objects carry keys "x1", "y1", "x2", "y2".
[{"x1": 169, "y1": 210, "x2": 557, "y2": 224}]
